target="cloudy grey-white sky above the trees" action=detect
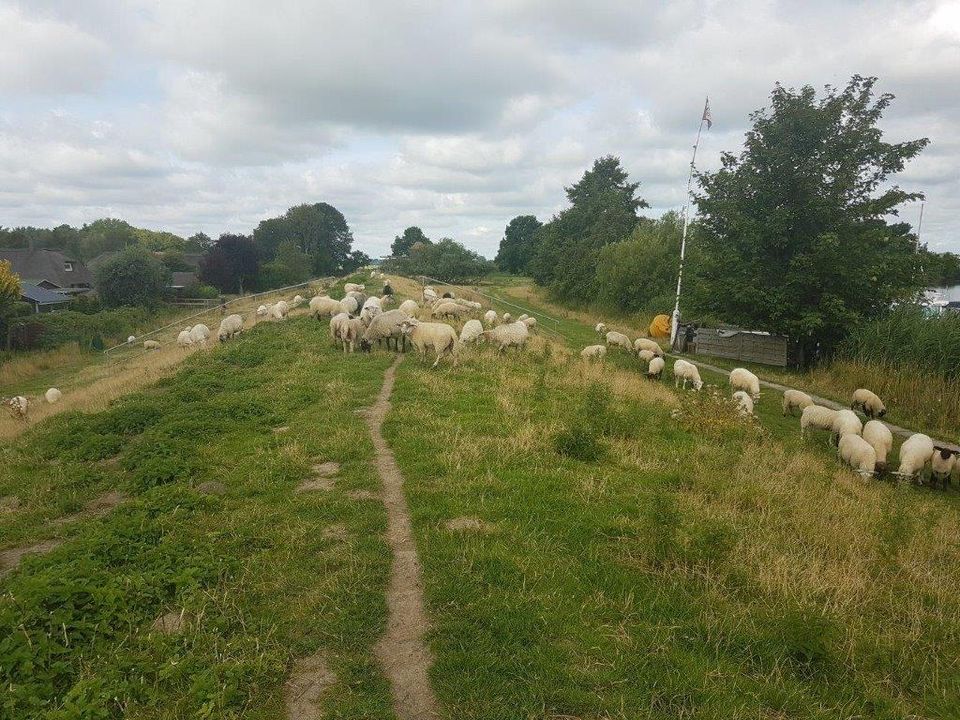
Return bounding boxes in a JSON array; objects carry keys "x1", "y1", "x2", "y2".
[{"x1": 0, "y1": 0, "x2": 960, "y2": 257}]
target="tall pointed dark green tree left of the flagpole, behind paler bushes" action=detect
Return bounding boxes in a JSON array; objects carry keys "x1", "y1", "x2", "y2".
[{"x1": 528, "y1": 155, "x2": 647, "y2": 302}]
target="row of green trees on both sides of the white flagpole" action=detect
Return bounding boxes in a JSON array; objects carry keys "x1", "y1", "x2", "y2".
[{"x1": 496, "y1": 76, "x2": 960, "y2": 357}]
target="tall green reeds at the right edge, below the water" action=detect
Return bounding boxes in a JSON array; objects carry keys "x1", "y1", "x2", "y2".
[{"x1": 839, "y1": 305, "x2": 960, "y2": 379}]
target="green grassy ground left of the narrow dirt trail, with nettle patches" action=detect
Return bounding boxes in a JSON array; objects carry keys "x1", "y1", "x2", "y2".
[{"x1": 0, "y1": 318, "x2": 392, "y2": 718}]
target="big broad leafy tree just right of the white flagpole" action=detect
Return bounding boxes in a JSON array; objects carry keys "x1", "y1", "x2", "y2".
[{"x1": 692, "y1": 76, "x2": 928, "y2": 357}]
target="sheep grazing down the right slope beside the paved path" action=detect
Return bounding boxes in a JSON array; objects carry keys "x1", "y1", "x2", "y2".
[{"x1": 580, "y1": 323, "x2": 960, "y2": 487}]
